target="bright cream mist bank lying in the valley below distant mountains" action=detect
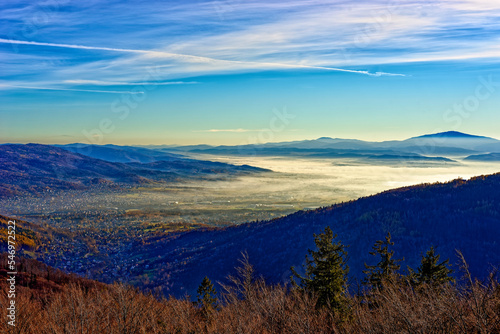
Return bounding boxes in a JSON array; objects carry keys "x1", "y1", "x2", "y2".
[{"x1": 187, "y1": 155, "x2": 500, "y2": 208}]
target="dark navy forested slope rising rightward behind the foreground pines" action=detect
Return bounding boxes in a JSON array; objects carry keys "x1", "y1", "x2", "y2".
[{"x1": 118, "y1": 173, "x2": 500, "y2": 296}]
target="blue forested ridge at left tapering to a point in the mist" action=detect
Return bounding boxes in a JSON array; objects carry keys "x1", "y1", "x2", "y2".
[{"x1": 0, "y1": 144, "x2": 268, "y2": 197}]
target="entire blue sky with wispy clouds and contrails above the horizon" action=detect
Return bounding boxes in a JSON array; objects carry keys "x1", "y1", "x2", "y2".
[{"x1": 0, "y1": 0, "x2": 500, "y2": 144}]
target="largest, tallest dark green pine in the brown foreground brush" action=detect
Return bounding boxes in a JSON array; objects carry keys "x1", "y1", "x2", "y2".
[{"x1": 291, "y1": 227, "x2": 349, "y2": 311}]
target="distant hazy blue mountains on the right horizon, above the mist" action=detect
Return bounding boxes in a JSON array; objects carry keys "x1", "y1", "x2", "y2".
[{"x1": 164, "y1": 131, "x2": 500, "y2": 164}]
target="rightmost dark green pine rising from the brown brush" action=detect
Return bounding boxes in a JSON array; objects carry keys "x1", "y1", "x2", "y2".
[{"x1": 412, "y1": 247, "x2": 453, "y2": 286}]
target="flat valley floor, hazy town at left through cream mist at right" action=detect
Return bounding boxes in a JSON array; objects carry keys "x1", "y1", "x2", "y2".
[{"x1": 0, "y1": 155, "x2": 500, "y2": 228}]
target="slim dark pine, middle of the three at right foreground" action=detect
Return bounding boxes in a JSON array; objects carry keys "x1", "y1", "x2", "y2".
[{"x1": 363, "y1": 232, "x2": 401, "y2": 290}]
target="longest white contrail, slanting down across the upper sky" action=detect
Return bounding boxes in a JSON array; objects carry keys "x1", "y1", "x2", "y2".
[{"x1": 0, "y1": 38, "x2": 405, "y2": 77}]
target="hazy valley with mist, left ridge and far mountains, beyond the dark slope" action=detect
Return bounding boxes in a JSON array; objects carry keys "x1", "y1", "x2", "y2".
[{"x1": 0, "y1": 133, "x2": 500, "y2": 229}]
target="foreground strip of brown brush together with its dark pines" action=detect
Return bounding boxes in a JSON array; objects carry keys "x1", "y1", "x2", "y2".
[{"x1": 0, "y1": 227, "x2": 500, "y2": 334}]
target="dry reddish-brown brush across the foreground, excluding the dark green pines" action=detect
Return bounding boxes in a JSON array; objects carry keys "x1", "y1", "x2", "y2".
[{"x1": 0, "y1": 257, "x2": 500, "y2": 334}]
